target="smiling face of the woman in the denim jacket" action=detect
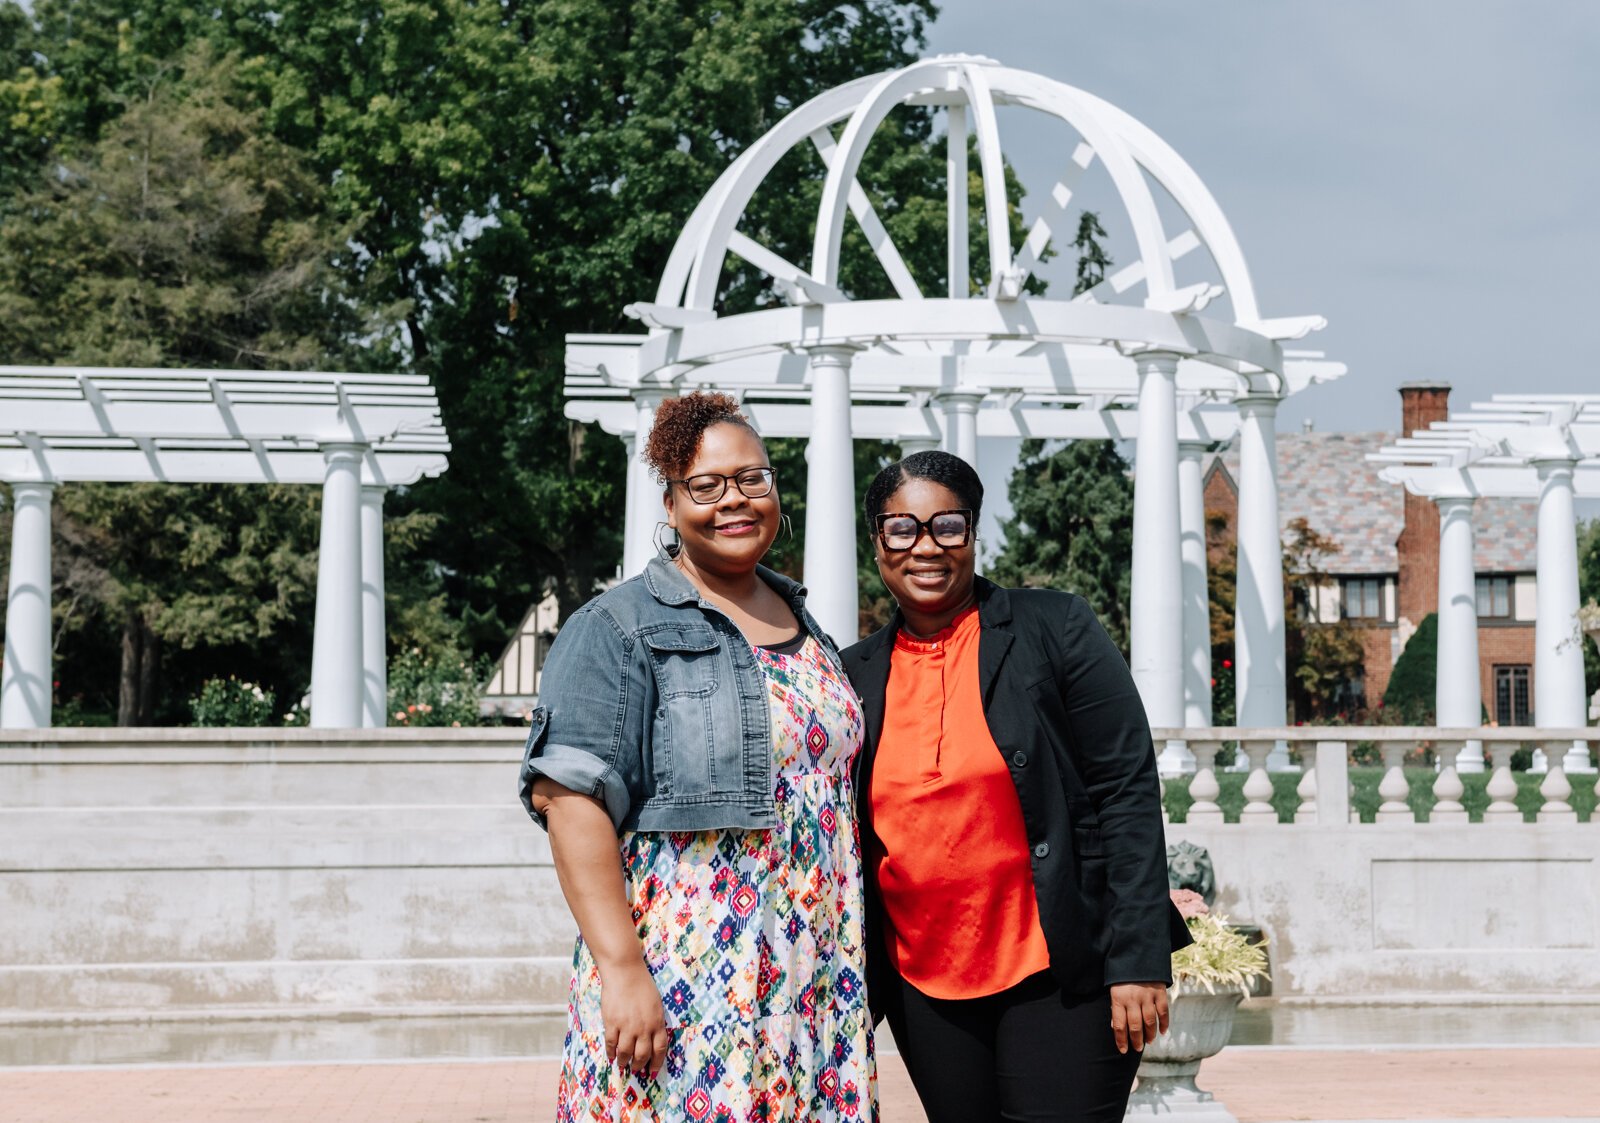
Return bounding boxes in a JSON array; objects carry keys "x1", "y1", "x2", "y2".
[{"x1": 664, "y1": 422, "x2": 782, "y2": 577}]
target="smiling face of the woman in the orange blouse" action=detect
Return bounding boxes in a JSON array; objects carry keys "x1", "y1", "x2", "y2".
[{"x1": 872, "y1": 478, "x2": 978, "y2": 635}]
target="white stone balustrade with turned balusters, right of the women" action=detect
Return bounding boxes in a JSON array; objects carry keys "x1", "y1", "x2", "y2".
[{"x1": 1152, "y1": 726, "x2": 1600, "y2": 825}]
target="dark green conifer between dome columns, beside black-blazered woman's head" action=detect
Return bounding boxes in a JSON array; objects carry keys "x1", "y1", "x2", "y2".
[{"x1": 994, "y1": 440, "x2": 1133, "y2": 654}]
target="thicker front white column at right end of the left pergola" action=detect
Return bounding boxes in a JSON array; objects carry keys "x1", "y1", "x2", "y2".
[{"x1": 310, "y1": 445, "x2": 363, "y2": 729}]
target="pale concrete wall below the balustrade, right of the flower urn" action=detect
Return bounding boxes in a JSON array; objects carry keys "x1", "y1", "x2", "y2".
[{"x1": 1166, "y1": 824, "x2": 1600, "y2": 1001}]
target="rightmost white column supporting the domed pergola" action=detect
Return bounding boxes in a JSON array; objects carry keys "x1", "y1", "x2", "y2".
[{"x1": 1234, "y1": 397, "x2": 1288, "y2": 771}]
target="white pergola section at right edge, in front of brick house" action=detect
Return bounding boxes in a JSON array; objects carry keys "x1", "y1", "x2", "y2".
[{"x1": 1371, "y1": 394, "x2": 1600, "y2": 773}]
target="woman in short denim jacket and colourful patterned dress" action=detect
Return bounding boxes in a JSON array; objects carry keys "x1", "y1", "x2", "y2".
[{"x1": 522, "y1": 394, "x2": 877, "y2": 1123}]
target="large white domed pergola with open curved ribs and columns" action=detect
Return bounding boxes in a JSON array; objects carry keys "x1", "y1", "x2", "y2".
[{"x1": 566, "y1": 56, "x2": 1344, "y2": 751}]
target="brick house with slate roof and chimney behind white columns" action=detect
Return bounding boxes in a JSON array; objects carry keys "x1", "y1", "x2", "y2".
[{"x1": 1205, "y1": 382, "x2": 1538, "y2": 725}]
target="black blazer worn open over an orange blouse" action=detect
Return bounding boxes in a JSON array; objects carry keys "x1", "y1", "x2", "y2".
[{"x1": 845, "y1": 577, "x2": 1190, "y2": 1005}]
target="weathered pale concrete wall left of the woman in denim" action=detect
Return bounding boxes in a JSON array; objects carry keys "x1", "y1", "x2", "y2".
[{"x1": 0, "y1": 729, "x2": 576, "y2": 1021}]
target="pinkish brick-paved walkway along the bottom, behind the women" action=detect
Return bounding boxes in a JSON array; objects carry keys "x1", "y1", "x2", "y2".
[{"x1": 0, "y1": 1048, "x2": 1600, "y2": 1123}]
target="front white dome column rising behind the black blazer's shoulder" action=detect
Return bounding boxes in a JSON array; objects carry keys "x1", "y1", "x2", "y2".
[{"x1": 1130, "y1": 355, "x2": 1184, "y2": 728}]
